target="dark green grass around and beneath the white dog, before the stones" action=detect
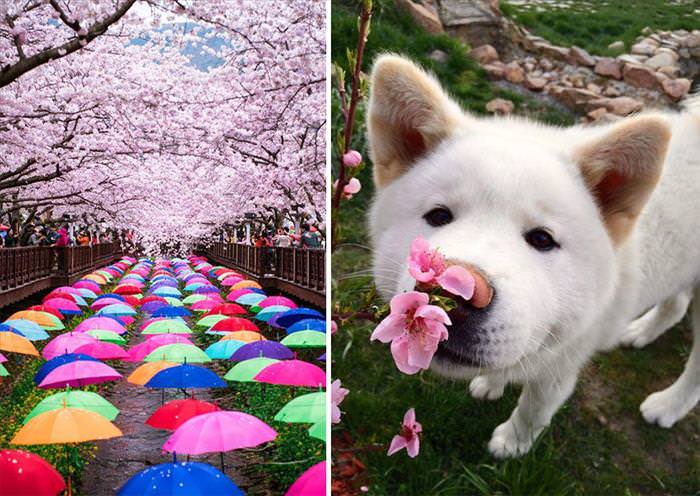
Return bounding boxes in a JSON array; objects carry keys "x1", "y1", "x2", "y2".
[{"x1": 332, "y1": 1, "x2": 700, "y2": 496}]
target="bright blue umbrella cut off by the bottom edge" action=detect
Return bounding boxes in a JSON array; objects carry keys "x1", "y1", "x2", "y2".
[{"x1": 117, "y1": 462, "x2": 245, "y2": 496}]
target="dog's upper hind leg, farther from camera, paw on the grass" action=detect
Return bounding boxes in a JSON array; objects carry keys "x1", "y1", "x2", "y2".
[{"x1": 620, "y1": 291, "x2": 690, "y2": 348}]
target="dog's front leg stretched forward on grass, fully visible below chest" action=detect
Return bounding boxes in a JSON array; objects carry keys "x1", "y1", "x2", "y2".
[{"x1": 489, "y1": 371, "x2": 577, "y2": 458}]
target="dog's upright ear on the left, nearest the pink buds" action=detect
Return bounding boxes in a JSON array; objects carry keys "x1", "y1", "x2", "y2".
[{"x1": 367, "y1": 55, "x2": 463, "y2": 187}]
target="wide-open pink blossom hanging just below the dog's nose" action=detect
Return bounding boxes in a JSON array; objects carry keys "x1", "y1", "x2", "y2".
[{"x1": 370, "y1": 291, "x2": 451, "y2": 374}]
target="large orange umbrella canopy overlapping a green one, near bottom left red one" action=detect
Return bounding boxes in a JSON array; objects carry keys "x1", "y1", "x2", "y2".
[{"x1": 10, "y1": 407, "x2": 122, "y2": 445}]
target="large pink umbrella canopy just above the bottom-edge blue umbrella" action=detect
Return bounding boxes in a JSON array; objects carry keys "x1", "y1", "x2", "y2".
[{"x1": 163, "y1": 411, "x2": 277, "y2": 455}]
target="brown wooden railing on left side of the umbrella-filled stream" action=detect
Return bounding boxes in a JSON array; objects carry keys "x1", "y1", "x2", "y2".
[{"x1": 0, "y1": 243, "x2": 121, "y2": 307}]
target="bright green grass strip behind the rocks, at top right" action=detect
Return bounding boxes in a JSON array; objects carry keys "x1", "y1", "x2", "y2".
[{"x1": 501, "y1": 0, "x2": 700, "y2": 55}]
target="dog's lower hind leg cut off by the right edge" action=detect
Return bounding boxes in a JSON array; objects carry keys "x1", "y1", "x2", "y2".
[{"x1": 639, "y1": 287, "x2": 700, "y2": 428}]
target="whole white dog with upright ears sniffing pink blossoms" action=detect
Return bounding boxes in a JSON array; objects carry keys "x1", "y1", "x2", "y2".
[{"x1": 368, "y1": 55, "x2": 700, "y2": 457}]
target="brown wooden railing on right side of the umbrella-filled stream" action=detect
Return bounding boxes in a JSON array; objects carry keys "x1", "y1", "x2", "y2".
[{"x1": 198, "y1": 243, "x2": 326, "y2": 307}]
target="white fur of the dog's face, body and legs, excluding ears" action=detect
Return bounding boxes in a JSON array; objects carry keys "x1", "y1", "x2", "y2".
[{"x1": 370, "y1": 55, "x2": 700, "y2": 457}]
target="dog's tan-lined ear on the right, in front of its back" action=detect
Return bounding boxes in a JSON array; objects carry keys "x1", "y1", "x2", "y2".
[{"x1": 574, "y1": 116, "x2": 671, "y2": 245}]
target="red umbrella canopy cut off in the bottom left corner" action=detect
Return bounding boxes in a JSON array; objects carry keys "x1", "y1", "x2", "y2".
[{"x1": 0, "y1": 449, "x2": 66, "y2": 496}]
